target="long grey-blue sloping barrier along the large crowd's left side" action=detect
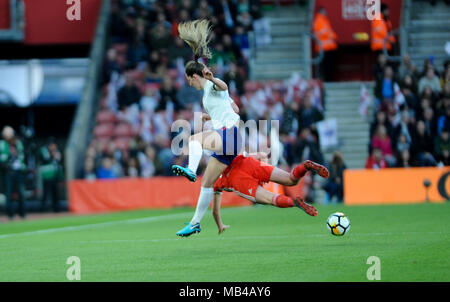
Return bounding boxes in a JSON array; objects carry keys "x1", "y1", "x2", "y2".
[{"x1": 65, "y1": 0, "x2": 111, "y2": 181}]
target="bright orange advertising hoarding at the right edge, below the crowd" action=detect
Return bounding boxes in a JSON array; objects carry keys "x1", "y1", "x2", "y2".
[{"x1": 344, "y1": 167, "x2": 450, "y2": 205}]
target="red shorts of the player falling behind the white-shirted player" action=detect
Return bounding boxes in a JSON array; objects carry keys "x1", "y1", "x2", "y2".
[{"x1": 214, "y1": 155, "x2": 274, "y2": 202}]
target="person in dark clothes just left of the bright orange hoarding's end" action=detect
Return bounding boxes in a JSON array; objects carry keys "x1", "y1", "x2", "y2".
[{"x1": 324, "y1": 151, "x2": 347, "y2": 204}]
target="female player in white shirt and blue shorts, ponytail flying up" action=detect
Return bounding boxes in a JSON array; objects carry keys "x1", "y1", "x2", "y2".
[{"x1": 172, "y1": 20, "x2": 242, "y2": 236}]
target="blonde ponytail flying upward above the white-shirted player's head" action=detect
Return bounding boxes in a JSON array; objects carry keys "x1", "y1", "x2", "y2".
[{"x1": 178, "y1": 19, "x2": 211, "y2": 62}]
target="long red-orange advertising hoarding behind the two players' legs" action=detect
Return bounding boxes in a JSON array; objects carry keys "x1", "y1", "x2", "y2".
[{"x1": 68, "y1": 177, "x2": 303, "y2": 214}]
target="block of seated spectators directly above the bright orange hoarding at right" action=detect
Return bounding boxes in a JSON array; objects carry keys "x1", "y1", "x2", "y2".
[{"x1": 366, "y1": 54, "x2": 450, "y2": 169}]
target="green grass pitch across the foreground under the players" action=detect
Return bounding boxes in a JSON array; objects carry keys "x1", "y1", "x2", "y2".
[{"x1": 0, "y1": 203, "x2": 450, "y2": 281}]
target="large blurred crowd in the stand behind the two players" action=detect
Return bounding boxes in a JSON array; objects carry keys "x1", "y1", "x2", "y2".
[{"x1": 82, "y1": 0, "x2": 324, "y2": 205}]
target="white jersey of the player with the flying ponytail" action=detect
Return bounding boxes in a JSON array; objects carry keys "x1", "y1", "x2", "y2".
[{"x1": 203, "y1": 80, "x2": 240, "y2": 129}]
